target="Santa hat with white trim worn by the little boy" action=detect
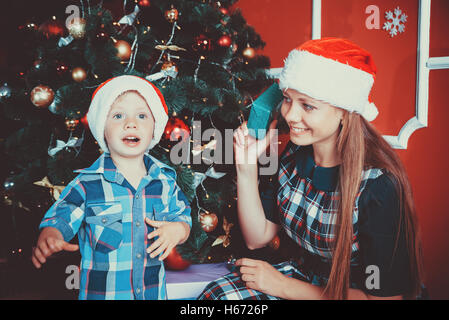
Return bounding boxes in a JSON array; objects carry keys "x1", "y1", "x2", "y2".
[{"x1": 87, "y1": 75, "x2": 168, "y2": 152}]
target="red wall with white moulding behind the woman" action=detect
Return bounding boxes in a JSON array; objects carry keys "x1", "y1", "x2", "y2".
[{"x1": 237, "y1": 0, "x2": 449, "y2": 299}]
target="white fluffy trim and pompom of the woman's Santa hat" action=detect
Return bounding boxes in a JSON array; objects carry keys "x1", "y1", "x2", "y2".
[{"x1": 279, "y1": 49, "x2": 378, "y2": 121}]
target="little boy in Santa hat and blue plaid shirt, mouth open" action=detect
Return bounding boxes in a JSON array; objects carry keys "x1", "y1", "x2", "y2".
[{"x1": 32, "y1": 75, "x2": 192, "y2": 299}]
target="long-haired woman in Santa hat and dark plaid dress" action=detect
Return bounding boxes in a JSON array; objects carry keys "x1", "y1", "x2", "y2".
[{"x1": 199, "y1": 38, "x2": 422, "y2": 299}]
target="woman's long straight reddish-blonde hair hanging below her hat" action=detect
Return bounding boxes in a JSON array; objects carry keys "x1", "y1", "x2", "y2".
[{"x1": 324, "y1": 111, "x2": 423, "y2": 299}]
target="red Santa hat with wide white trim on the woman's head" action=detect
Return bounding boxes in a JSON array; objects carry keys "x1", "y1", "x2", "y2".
[{"x1": 279, "y1": 38, "x2": 379, "y2": 121}]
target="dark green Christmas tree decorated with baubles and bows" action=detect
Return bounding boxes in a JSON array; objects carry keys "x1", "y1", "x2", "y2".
[{"x1": 0, "y1": 0, "x2": 272, "y2": 263}]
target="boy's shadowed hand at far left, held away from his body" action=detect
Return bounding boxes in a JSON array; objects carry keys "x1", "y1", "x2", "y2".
[{"x1": 31, "y1": 227, "x2": 79, "y2": 269}]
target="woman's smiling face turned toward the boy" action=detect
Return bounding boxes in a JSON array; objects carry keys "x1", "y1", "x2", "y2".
[{"x1": 281, "y1": 89, "x2": 343, "y2": 146}]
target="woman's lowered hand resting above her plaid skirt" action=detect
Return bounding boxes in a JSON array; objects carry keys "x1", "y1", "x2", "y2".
[{"x1": 235, "y1": 258, "x2": 287, "y2": 297}]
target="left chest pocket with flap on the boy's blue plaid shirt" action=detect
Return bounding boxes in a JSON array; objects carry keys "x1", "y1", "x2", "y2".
[{"x1": 86, "y1": 202, "x2": 123, "y2": 253}]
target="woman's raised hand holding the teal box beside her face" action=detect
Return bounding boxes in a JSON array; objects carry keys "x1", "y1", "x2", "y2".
[{"x1": 234, "y1": 120, "x2": 277, "y2": 175}]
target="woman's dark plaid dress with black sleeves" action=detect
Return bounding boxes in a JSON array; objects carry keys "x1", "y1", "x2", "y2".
[{"x1": 198, "y1": 142, "x2": 410, "y2": 300}]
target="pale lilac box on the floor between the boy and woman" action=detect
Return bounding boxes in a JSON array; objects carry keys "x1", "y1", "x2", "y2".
[{"x1": 166, "y1": 263, "x2": 230, "y2": 300}]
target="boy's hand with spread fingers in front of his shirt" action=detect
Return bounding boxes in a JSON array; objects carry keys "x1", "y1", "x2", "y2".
[{"x1": 145, "y1": 218, "x2": 190, "y2": 260}]
